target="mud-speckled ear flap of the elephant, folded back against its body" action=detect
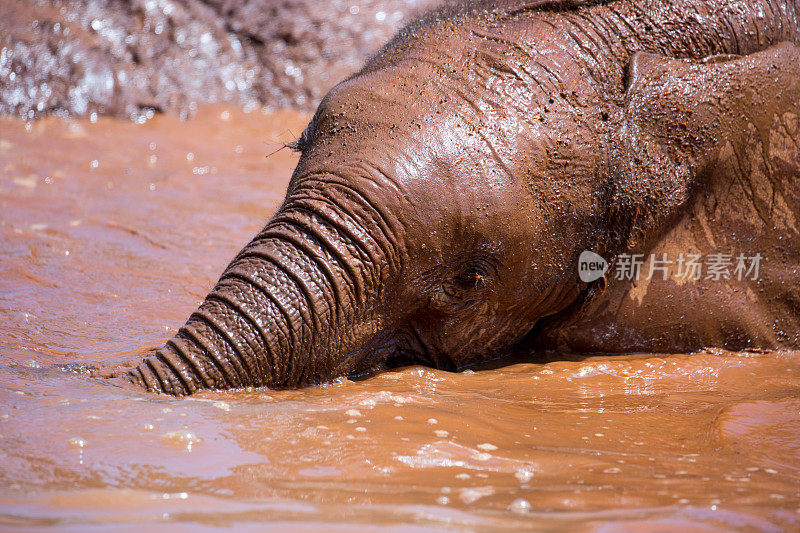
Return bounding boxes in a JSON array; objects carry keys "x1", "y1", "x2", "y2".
[{"x1": 607, "y1": 43, "x2": 800, "y2": 256}]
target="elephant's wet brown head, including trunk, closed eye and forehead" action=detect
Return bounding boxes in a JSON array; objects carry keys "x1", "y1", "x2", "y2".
[{"x1": 128, "y1": 0, "x2": 800, "y2": 395}]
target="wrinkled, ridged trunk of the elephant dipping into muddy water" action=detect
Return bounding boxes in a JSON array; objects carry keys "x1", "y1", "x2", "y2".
[{"x1": 128, "y1": 189, "x2": 385, "y2": 395}]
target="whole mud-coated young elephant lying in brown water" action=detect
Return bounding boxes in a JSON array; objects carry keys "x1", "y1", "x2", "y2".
[{"x1": 122, "y1": 0, "x2": 800, "y2": 395}]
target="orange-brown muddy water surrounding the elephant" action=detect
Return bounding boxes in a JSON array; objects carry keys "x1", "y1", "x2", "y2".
[{"x1": 0, "y1": 109, "x2": 800, "y2": 532}]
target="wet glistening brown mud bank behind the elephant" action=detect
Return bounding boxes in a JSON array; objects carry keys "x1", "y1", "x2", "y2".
[{"x1": 0, "y1": 0, "x2": 440, "y2": 119}]
